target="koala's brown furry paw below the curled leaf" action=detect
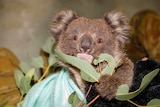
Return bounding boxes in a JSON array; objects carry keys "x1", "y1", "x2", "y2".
[{"x1": 95, "y1": 76, "x2": 119, "y2": 100}]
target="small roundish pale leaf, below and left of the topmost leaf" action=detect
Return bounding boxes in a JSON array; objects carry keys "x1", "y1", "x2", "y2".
[{"x1": 32, "y1": 56, "x2": 44, "y2": 68}]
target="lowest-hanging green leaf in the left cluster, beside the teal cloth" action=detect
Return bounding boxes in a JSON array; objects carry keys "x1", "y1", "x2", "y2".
[{"x1": 20, "y1": 77, "x2": 31, "y2": 96}]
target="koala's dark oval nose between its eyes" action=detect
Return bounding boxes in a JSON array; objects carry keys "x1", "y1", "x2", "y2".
[{"x1": 80, "y1": 36, "x2": 92, "y2": 52}]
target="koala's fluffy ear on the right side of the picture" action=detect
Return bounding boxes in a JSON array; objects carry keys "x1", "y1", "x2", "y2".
[{"x1": 104, "y1": 11, "x2": 130, "y2": 43}]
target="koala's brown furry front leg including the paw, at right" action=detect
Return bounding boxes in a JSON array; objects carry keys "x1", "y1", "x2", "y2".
[{"x1": 95, "y1": 58, "x2": 134, "y2": 100}]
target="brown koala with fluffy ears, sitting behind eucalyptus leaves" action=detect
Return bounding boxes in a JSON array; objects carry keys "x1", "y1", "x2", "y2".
[{"x1": 50, "y1": 10, "x2": 134, "y2": 100}]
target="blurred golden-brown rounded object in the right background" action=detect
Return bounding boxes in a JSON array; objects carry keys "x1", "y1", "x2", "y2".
[{"x1": 126, "y1": 10, "x2": 160, "y2": 61}]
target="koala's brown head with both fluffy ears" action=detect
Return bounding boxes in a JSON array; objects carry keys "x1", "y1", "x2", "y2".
[{"x1": 51, "y1": 10, "x2": 130, "y2": 63}]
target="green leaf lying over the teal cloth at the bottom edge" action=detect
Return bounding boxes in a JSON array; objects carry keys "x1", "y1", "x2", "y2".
[{"x1": 68, "y1": 92, "x2": 81, "y2": 107}]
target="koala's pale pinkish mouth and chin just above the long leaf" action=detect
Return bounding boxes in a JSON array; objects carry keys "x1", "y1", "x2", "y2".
[{"x1": 77, "y1": 53, "x2": 93, "y2": 64}]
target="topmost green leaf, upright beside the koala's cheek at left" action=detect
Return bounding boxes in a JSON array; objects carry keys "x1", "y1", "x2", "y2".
[{"x1": 42, "y1": 37, "x2": 55, "y2": 54}]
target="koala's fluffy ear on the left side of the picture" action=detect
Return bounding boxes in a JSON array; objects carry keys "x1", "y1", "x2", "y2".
[{"x1": 50, "y1": 10, "x2": 78, "y2": 40}]
